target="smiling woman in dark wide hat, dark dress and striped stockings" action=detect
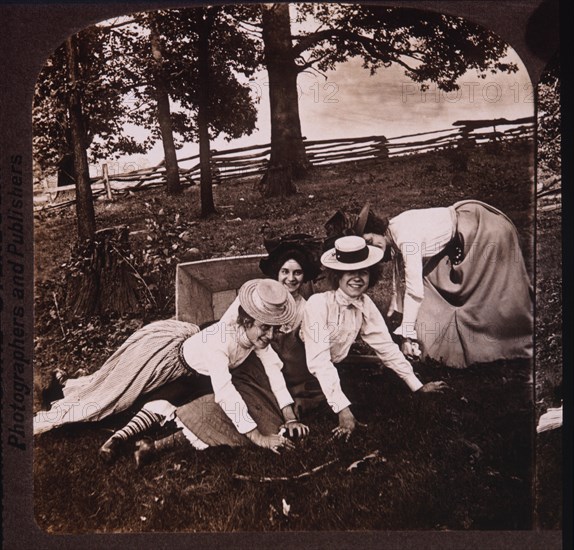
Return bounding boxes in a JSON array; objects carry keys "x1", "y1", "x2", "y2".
[{"x1": 95, "y1": 234, "x2": 325, "y2": 465}]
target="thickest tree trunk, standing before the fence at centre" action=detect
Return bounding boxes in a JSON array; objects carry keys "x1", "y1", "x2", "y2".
[{"x1": 261, "y1": 4, "x2": 310, "y2": 197}]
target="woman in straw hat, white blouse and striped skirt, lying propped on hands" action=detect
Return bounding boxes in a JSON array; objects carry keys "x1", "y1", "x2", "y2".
[{"x1": 34, "y1": 279, "x2": 307, "y2": 455}]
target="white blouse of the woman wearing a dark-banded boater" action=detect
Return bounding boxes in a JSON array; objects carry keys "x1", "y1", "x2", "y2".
[{"x1": 301, "y1": 289, "x2": 422, "y2": 413}]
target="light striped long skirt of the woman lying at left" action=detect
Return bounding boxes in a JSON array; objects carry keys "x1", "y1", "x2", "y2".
[{"x1": 34, "y1": 320, "x2": 199, "y2": 434}]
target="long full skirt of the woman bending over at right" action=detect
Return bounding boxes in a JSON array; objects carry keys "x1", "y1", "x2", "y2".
[{"x1": 417, "y1": 201, "x2": 534, "y2": 368}]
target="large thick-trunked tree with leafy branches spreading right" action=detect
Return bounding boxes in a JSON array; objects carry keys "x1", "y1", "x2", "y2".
[{"x1": 236, "y1": 3, "x2": 517, "y2": 197}]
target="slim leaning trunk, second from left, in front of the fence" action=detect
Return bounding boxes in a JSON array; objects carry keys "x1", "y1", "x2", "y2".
[{"x1": 150, "y1": 20, "x2": 182, "y2": 195}]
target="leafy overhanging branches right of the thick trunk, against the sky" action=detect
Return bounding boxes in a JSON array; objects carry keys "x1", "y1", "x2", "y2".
[{"x1": 294, "y1": 4, "x2": 517, "y2": 91}]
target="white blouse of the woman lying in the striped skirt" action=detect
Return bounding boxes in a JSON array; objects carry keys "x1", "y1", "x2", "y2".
[{"x1": 182, "y1": 299, "x2": 293, "y2": 434}]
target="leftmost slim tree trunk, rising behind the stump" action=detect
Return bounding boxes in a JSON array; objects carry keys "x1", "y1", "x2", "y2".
[{"x1": 66, "y1": 36, "x2": 96, "y2": 241}]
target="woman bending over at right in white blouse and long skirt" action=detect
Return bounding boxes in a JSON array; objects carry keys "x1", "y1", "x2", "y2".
[{"x1": 360, "y1": 200, "x2": 533, "y2": 368}]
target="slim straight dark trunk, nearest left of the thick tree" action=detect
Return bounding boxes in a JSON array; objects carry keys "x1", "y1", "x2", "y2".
[{"x1": 197, "y1": 8, "x2": 217, "y2": 218}]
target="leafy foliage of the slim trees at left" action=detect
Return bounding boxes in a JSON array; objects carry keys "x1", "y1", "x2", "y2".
[{"x1": 33, "y1": 6, "x2": 260, "y2": 181}]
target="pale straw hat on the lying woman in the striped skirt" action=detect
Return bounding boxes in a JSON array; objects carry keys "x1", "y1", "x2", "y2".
[{"x1": 239, "y1": 279, "x2": 297, "y2": 325}]
